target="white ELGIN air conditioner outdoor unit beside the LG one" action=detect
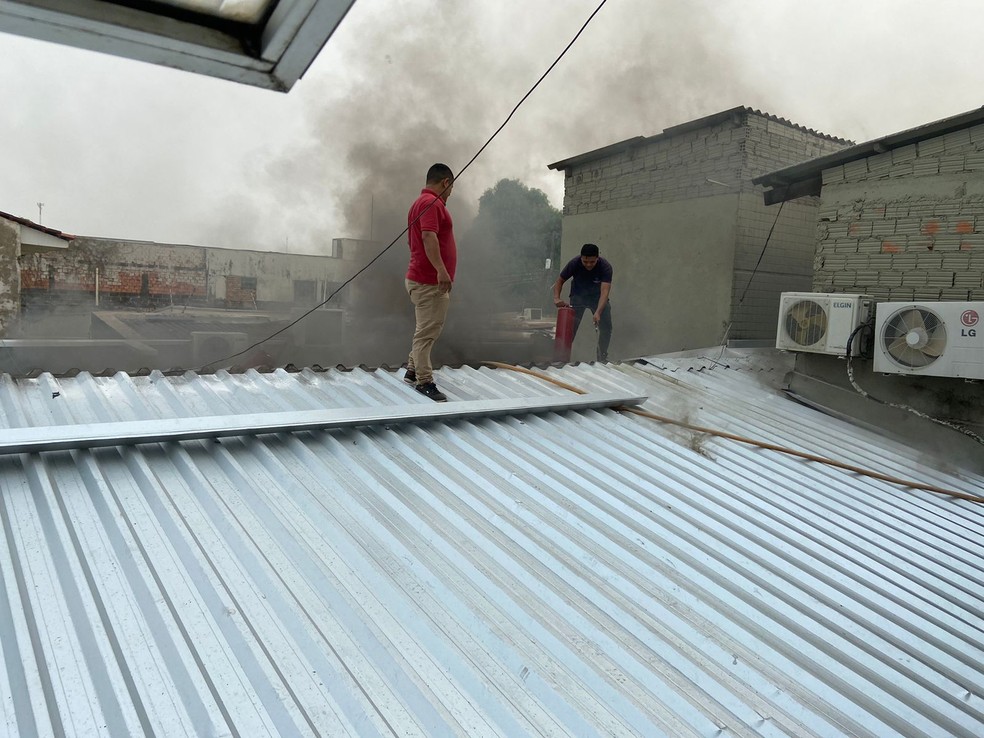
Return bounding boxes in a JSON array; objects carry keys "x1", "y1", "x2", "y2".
[{"x1": 776, "y1": 292, "x2": 873, "y2": 356}]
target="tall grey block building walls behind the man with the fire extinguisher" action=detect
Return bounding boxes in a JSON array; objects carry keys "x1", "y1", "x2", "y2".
[{"x1": 561, "y1": 109, "x2": 850, "y2": 356}]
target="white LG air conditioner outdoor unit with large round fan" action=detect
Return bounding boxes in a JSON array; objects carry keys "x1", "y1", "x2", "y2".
[{"x1": 874, "y1": 302, "x2": 984, "y2": 379}]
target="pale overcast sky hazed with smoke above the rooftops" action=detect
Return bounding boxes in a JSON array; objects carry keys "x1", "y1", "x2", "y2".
[{"x1": 0, "y1": 0, "x2": 984, "y2": 254}]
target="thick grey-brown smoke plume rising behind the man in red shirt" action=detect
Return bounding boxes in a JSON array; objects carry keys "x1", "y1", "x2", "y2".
[{"x1": 198, "y1": 0, "x2": 752, "y2": 363}]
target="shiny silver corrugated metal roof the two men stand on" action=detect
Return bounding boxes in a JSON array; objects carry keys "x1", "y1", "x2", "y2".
[{"x1": 0, "y1": 357, "x2": 984, "y2": 738}]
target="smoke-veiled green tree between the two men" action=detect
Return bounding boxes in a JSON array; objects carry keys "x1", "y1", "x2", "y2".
[{"x1": 462, "y1": 179, "x2": 561, "y2": 310}]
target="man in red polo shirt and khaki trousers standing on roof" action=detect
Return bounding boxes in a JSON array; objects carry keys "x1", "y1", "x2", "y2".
[{"x1": 403, "y1": 164, "x2": 458, "y2": 402}]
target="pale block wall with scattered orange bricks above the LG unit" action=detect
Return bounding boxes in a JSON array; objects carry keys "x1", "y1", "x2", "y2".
[{"x1": 813, "y1": 125, "x2": 984, "y2": 301}]
